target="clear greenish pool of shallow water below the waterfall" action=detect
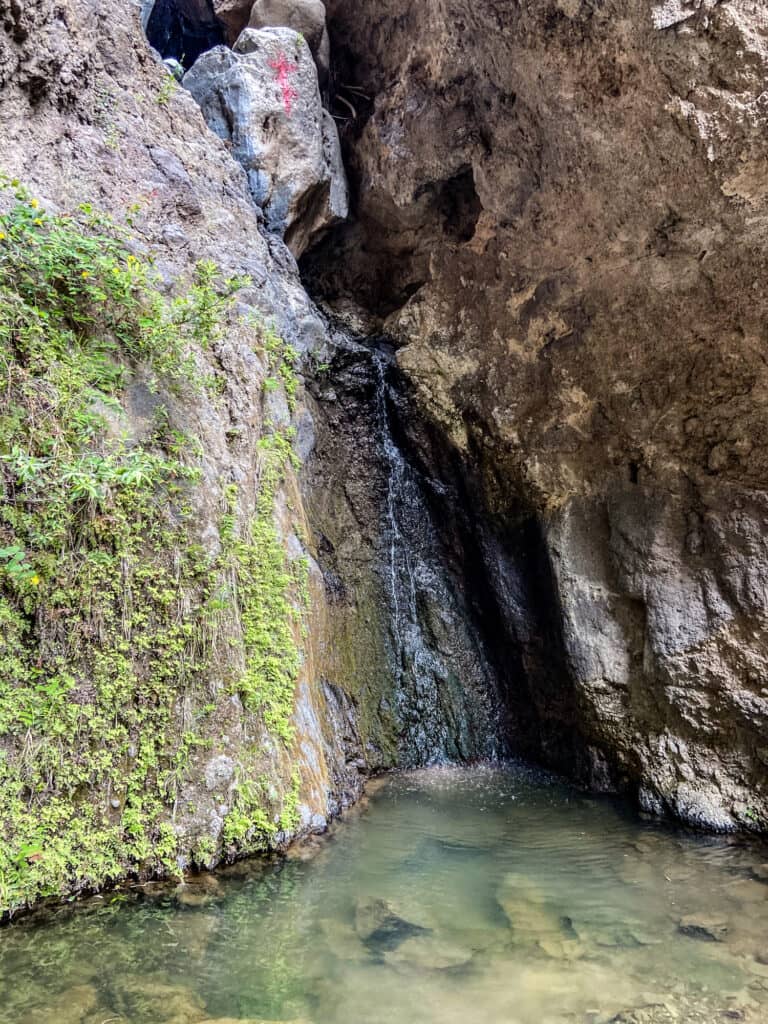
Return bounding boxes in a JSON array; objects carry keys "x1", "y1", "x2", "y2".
[{"x1": 0, "y1": 768, "x2": 768, "y2": 1024}]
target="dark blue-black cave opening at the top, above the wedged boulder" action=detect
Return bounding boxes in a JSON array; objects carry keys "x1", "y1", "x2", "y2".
[{"x1": 144, "y1": 0, "x2": 224, "y2": 69}]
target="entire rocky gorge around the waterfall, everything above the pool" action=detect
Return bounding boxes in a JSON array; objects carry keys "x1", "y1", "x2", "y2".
[{"x1": 0, "y1": 0, "x2": 768, "y2": 909}]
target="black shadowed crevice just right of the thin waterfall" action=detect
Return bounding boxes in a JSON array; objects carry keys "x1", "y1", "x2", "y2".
[{"x1": 390, "y1": 368, "x2": 589, "y2": 780}]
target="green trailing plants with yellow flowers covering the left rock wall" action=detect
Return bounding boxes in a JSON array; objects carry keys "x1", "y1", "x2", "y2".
[{"x1": 0, "y1": 179, "x2": 309, "y2": 912}]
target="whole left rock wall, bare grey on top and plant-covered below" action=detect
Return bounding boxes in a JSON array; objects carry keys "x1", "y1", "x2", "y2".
[{"x1": 0, "y1": 0, "x2": 389, "y2": 911}]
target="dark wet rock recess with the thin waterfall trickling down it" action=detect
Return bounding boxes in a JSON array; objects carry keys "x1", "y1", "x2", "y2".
[{"x1": 307, "y1": 323, "x2": 587, "y2": 777}]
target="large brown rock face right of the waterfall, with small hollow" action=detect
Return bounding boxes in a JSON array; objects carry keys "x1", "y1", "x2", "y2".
[{"x1": 306, "y1": 0, "x2": 768, "y2": 828}]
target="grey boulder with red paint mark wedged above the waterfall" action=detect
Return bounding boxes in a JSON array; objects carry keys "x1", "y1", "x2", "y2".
[{"x1": 183, "y1": 28, "x2": 348, "y2": 258}]
